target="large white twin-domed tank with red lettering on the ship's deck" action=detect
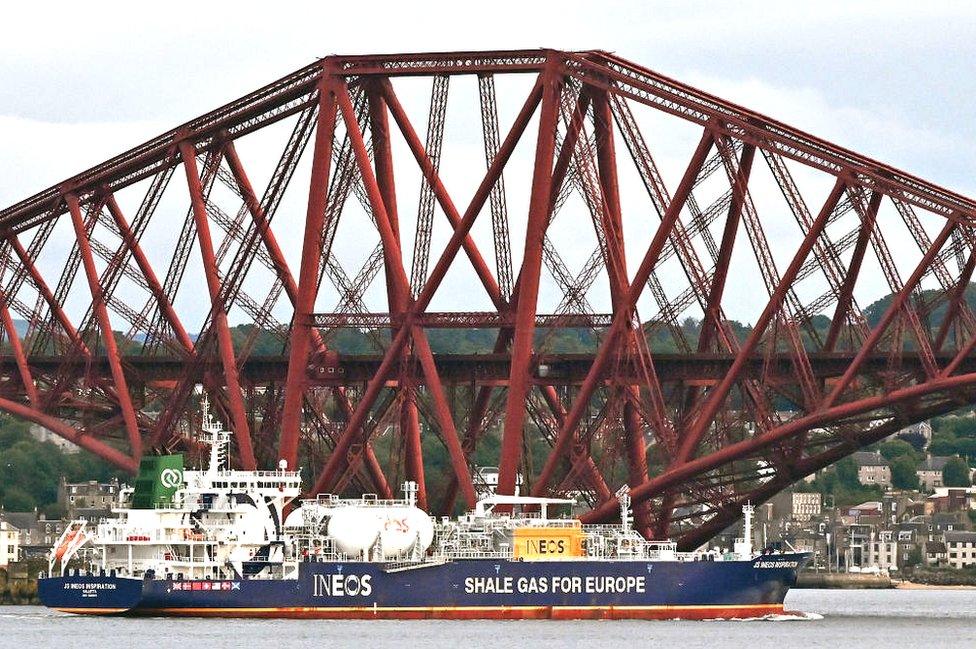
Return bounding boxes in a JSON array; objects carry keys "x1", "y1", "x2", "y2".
[{"x1": 328, "y1": 506, "x2": 434, "y2": 559}]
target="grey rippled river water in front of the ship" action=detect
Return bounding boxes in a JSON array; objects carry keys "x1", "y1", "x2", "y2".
[{"x1": 0, "y1": 590, "x2": 976, "y2": 649}]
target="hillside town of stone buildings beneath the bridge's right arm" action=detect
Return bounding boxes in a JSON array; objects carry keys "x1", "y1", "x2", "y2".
[{"x1": 713, "y1": 412, "x2": 976, "y2": 585}]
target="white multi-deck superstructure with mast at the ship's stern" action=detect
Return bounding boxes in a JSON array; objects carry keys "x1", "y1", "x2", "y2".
[{"x1": 51, "y1": 412, "x2": 301, "y2": 579}]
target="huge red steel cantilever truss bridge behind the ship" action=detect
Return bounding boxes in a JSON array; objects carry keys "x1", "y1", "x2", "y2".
[{"x1": 0, "y1": 50, "x2": 976, "y2": 547}]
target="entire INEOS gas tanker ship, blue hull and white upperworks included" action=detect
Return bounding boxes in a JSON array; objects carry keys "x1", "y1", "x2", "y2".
[{"x1": 38, "y1": 410, "x2": 810, "y2": 619}]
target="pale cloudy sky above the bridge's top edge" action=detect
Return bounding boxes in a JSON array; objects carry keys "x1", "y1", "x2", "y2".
[{"x1": 0, "y1": 0, "x2": 976, "y2": 324}]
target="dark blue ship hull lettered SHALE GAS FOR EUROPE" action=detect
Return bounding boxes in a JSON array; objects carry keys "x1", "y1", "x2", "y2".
[{"x1": 38, "y1": 553, "x2": 810, "y2": 619}]
